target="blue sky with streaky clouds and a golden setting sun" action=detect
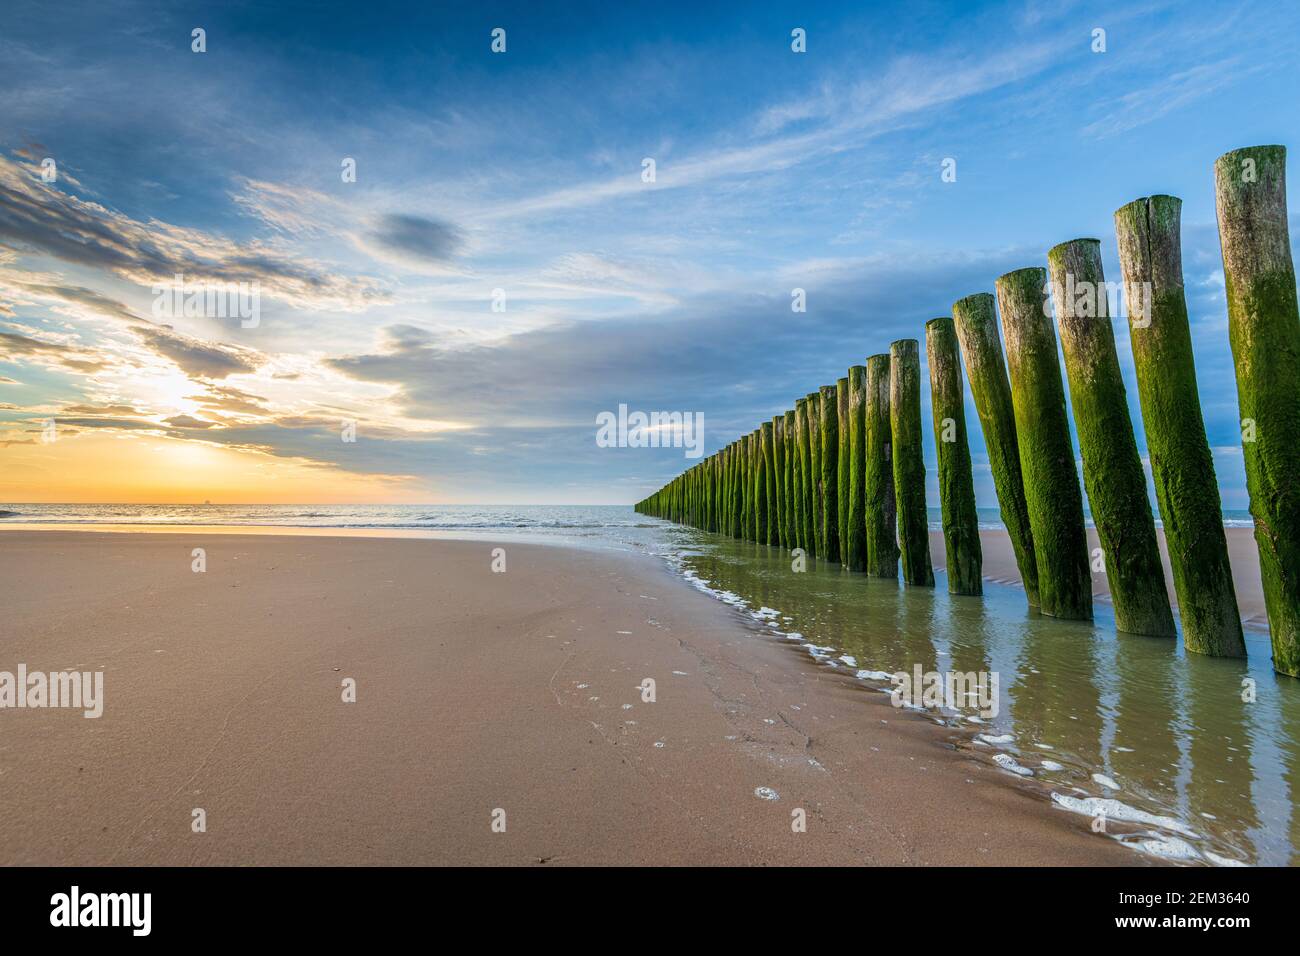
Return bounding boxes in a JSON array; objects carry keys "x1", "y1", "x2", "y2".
[{"x1": 0, "y1": 0, "x2": 1300, "y2": 509}]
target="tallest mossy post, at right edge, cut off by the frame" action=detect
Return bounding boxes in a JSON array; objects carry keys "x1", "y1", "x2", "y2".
[{"x1": 1214, "y1": 146, "x2": 1300, "y2": 676}]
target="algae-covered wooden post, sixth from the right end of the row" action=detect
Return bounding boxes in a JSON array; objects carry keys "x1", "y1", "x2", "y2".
[{"x1": 926, "y1": 319, "x2": 984, "y2": 594}]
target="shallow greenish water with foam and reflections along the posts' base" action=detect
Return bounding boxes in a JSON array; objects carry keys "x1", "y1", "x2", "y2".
[{"x1": 670, "y1": 528, "x2": 1300, "y2": 865}]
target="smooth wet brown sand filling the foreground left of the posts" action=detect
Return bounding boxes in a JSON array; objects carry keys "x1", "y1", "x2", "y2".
[{"x1": 0, "y1": 531, "x2": 1148, "y2": 865}]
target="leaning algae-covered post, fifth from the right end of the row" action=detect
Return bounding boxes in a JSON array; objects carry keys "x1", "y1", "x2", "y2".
[{"x1": 953, "y1": 293, "x2": 1039, "y2": 607}]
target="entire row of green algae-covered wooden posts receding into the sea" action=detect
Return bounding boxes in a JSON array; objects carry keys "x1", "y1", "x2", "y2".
[{"x1": 636, "y1": 146, "x2": 1300, "y2": 676}]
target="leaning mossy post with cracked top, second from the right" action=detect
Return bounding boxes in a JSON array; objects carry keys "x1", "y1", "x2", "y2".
[{"x1": 1115, "y1": 196, "x2": 1245, "y2": 657}]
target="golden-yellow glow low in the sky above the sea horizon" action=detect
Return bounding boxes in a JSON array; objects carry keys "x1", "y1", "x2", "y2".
[{"x1": 0, "y1": 432, "x2": 430, "y2": 505}]
